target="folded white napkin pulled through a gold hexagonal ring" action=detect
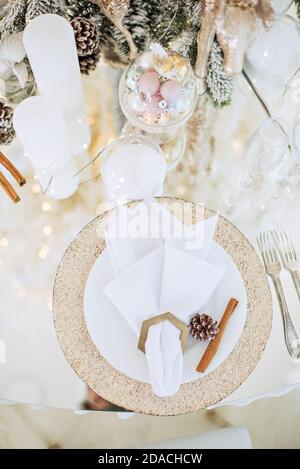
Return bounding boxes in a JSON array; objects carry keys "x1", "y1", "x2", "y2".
[{"x1": 103, "y1": 202, "x2": 225, "y2": 397}]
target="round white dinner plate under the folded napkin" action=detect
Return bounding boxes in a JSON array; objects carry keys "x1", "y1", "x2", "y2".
[{"x1": 84, "y1": 241, "x2": 247, "y2": 383}]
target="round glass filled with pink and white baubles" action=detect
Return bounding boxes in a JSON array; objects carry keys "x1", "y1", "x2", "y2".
[{"x1": 119, "y1": 44, "x2": 197, "y2": 133}]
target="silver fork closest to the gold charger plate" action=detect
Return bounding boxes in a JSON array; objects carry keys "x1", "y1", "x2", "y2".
[{"x1": 257, "y1": 231, "x2": 300, "y2": 360}]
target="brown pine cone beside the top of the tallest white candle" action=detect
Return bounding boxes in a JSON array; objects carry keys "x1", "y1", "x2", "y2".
[{"x1": 71, "y1": 16, "x2": 99, "y2": 57}]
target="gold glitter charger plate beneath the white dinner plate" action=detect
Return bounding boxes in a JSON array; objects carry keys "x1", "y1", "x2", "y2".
[{"x1": 53, "y1": 197, "x2": 272, "y2": 415}]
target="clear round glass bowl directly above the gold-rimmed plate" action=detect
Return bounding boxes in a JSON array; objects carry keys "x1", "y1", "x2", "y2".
[{"x1": 101, "y1": 134, "x2": 167, "y2": 204}]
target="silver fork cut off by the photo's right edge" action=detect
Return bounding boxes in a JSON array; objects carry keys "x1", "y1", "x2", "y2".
[{"x1": 272, "y1": 223, "x2": 300, "y2": 300}]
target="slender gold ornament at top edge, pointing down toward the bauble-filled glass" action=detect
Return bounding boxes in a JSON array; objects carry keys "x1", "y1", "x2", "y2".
[{"x1": 91, "y1": 0, "x2": 138, "y2": 61}]
